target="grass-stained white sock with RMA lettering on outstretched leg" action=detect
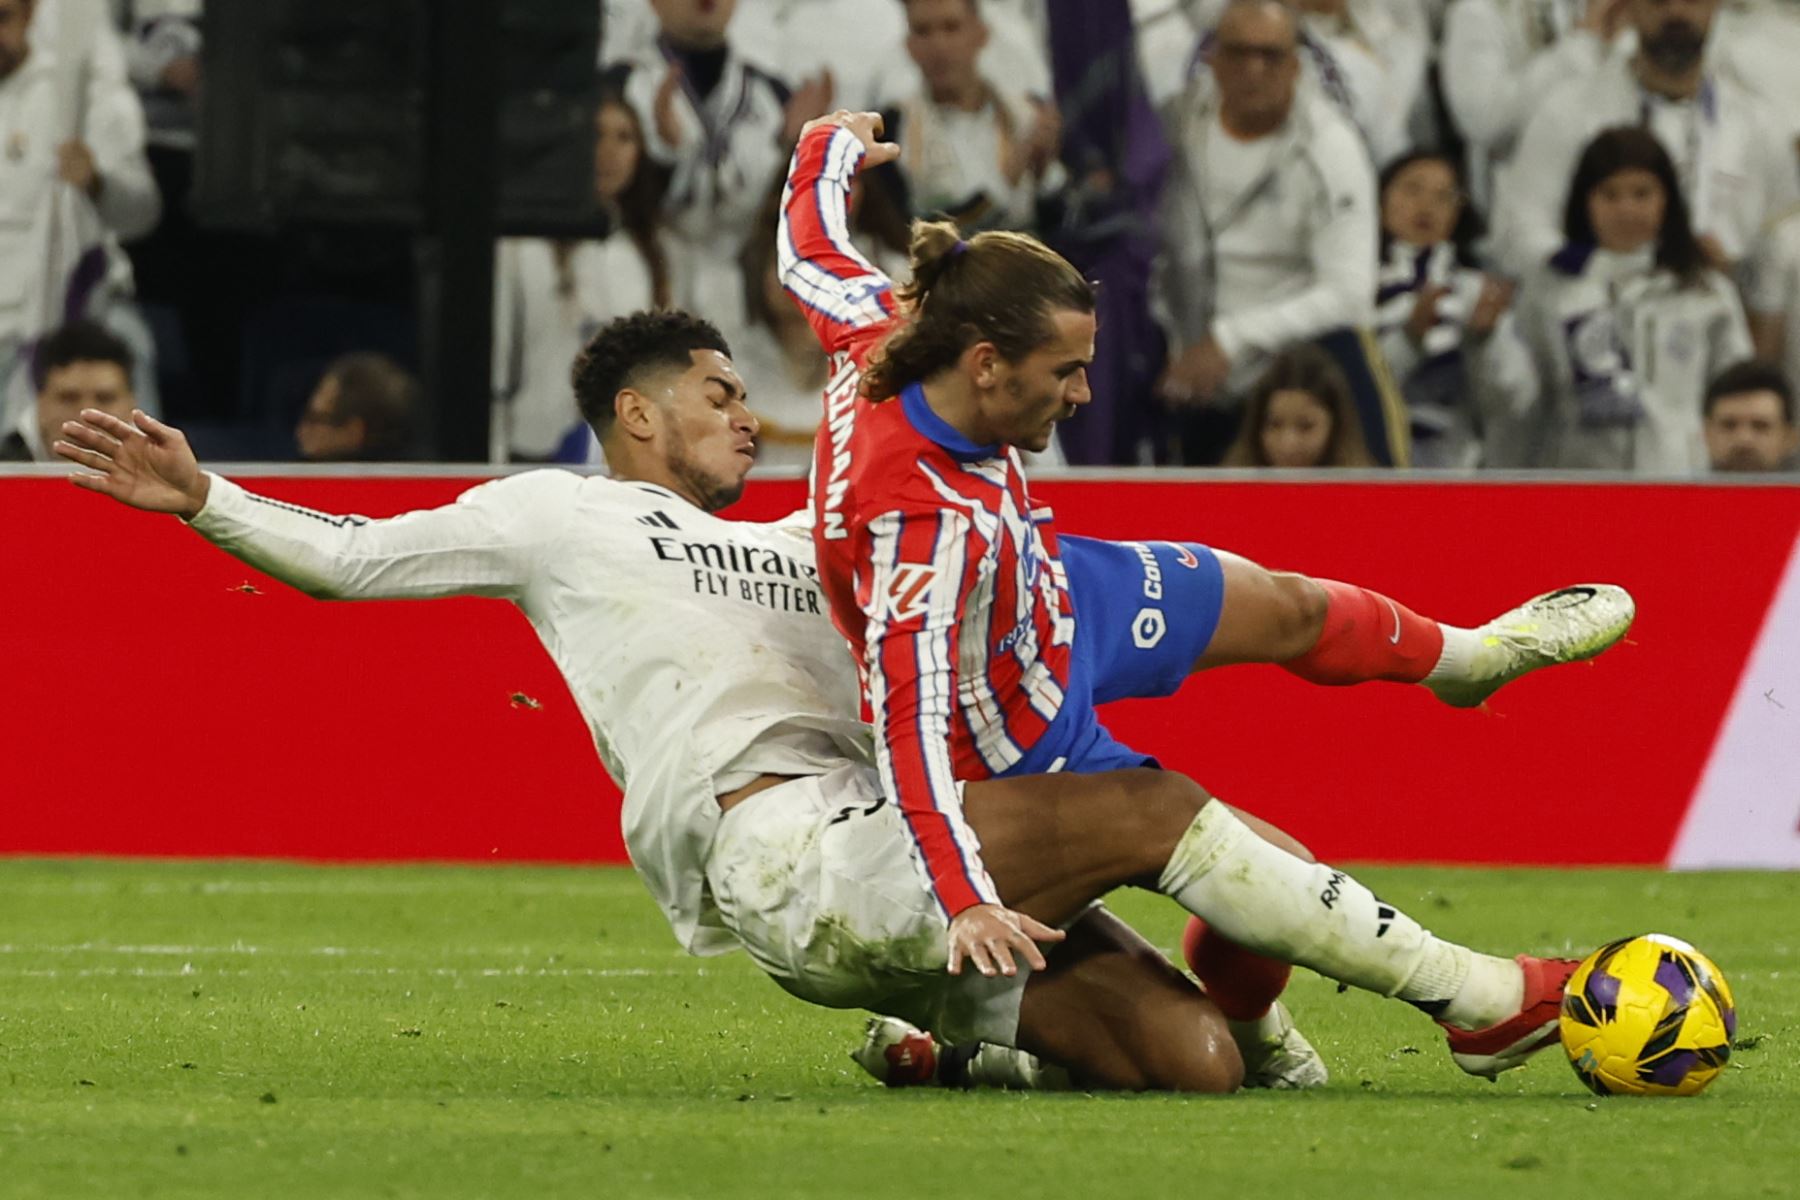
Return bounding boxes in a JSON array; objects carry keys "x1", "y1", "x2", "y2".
[{"x1": 1157, "y1": 801, "x2": 1525, "y2": 1029}]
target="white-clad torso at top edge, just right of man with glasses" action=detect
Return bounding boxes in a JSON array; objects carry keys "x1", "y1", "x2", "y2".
[{"x1": 1298, "y1": 0, "x2": 1431, "y2": 166}]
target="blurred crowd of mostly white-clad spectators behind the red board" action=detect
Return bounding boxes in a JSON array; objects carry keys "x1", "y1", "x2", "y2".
[{"x1": 0, "y1": 0, "x2": 1800, "y2": 475}]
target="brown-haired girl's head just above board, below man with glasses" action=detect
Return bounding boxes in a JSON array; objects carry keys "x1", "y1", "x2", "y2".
[{"x1": 1224, "y1": 344, "x2": 1375, "y2": 468}]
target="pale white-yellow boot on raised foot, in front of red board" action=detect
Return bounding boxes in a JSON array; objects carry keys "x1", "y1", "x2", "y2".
[{"x1": 1426, "y1": 583, "x2": 1638, "y2": 709}]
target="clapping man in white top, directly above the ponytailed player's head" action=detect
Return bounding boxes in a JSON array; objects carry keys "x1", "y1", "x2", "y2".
[{"x1": 887, "y1": 0, "x2": 1062, "y2": 232}]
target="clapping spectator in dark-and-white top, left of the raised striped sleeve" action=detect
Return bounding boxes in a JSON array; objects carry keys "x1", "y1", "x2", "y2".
[{"x1": 608, "y1": 0, "x2": 832, "y2": 329}]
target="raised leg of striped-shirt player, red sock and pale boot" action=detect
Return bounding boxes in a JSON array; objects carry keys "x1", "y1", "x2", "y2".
[{"x1": 1193, "y1": 551, "x2": 1636, "y2": 707}]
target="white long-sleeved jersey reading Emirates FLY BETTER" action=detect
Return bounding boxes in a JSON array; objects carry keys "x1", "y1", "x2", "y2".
[{"x1": 193, "y1": 471, "x2": 873, "y2": 954}]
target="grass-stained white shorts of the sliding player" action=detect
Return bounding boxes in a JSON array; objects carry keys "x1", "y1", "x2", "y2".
[{"x1": 706, "y1": 765, "x2": 1030, "y2": 1045}]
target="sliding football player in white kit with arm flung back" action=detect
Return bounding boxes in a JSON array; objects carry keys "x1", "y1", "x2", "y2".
[{"x1": 56, "y1": 313, "x2": 1612, "y2": 1092}]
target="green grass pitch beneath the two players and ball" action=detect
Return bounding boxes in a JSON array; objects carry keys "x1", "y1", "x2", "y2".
[{"x1": 0, "y1": 860, "x2": 1800, "y2": 1200}]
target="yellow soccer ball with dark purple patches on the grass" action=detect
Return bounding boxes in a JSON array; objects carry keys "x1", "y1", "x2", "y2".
[{"x1": 1561, "y1": 934, "x2": 1737, "y2": 1096}]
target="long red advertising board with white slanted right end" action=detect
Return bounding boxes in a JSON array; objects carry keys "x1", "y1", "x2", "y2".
[{"x1": 0, "y1": 475, "x2": 1800, "y2": 865}]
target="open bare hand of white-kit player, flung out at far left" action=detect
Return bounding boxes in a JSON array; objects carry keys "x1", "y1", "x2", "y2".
[{"x1": 52, "y1": 408, "x2": 207, "y2": 518}]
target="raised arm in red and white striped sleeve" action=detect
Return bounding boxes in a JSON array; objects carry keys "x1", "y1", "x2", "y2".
[{"x1": 776, "y1": 110, "x2": 900, "y2": 353}]
